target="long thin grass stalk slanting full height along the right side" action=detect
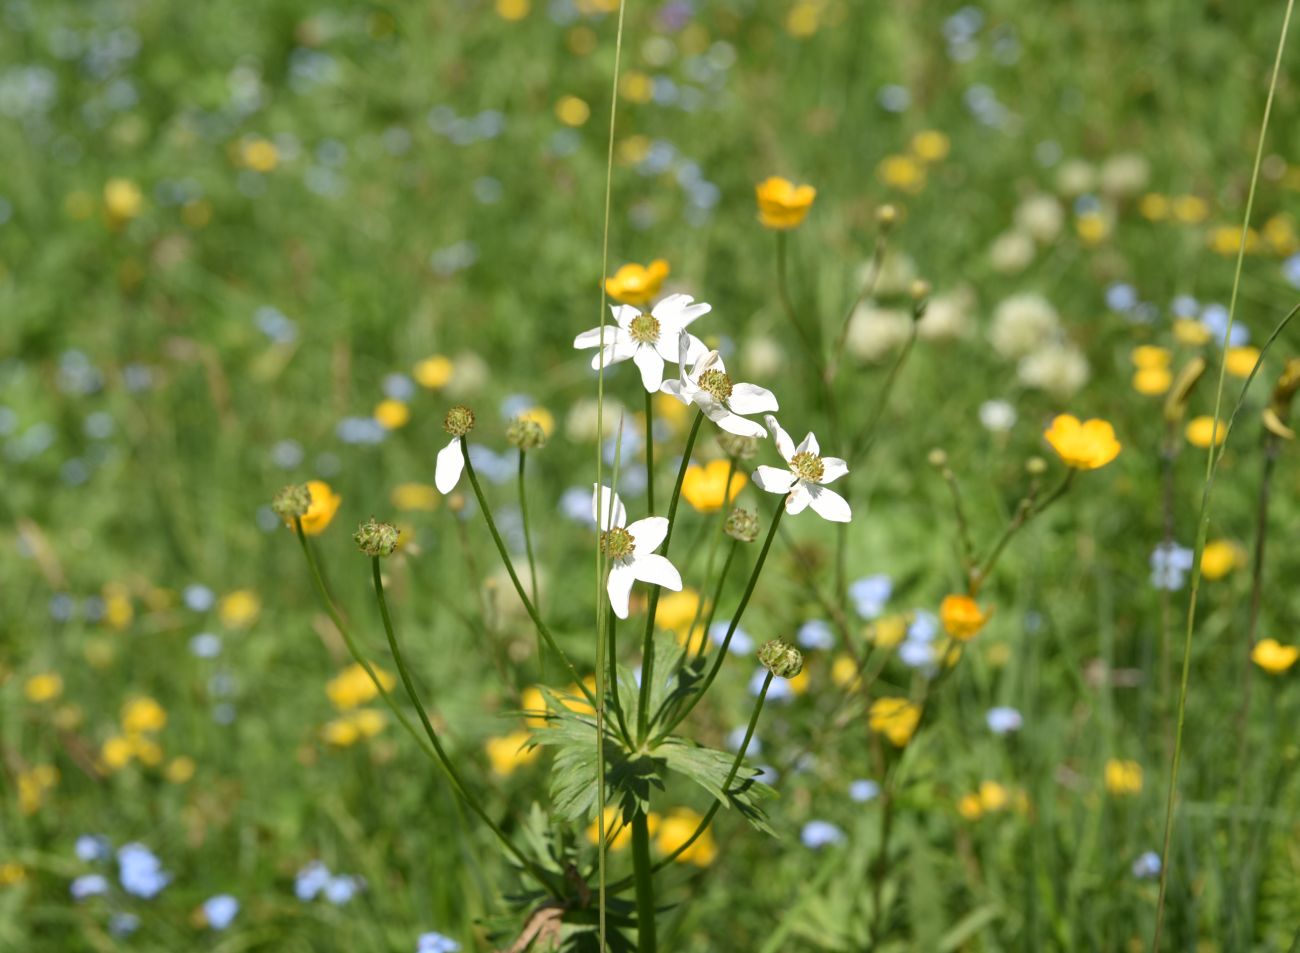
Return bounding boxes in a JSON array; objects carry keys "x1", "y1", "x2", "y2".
[{"x1": 1151, "y1": 0, "x2": 1295, "y2": 953}]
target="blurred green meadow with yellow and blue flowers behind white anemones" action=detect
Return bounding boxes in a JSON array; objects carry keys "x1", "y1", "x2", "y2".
[{"x1": 0, "y1": 0, "x2": 1300, "y2": 953}]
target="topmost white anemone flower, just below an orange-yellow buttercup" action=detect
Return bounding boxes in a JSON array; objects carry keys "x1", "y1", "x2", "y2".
[{"x1": 573, "y1": 295, "x2": 712, "y2": 394}]
